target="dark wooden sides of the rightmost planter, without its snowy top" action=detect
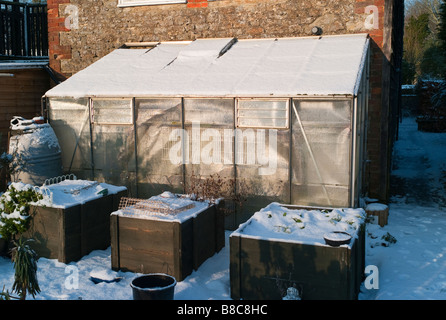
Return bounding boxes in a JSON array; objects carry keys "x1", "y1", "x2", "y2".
[{"x1": 229, "y1": 205, "x2": 365, "y2": 300}]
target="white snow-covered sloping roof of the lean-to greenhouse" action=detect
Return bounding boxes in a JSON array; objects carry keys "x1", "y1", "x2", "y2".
[{"x1": 46, "y1": 34, "x2": 369, "y2": 97}]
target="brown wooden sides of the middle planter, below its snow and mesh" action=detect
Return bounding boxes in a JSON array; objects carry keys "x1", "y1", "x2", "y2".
[{"x1": 110, "y1": 205, "x2": 224, "y2": 281}]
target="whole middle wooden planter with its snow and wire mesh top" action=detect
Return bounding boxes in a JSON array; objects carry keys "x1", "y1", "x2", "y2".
[{"x1": 111, "y1": 192, "x2": 224, "y2": 281}]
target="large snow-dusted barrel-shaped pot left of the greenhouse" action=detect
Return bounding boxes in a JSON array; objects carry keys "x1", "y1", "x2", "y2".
[{"x1": 9, "y1": 116, "x2": 62, "y2": 185}]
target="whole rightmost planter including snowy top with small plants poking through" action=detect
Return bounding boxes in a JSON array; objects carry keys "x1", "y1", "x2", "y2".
[{"x1": 230, "y1": 203, "x2": 366, "y2": 300}]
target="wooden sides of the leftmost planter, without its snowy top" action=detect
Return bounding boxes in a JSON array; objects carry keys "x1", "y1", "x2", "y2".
[{"x1": 24, "y1": 190, "x2": 127, "y2": 263}]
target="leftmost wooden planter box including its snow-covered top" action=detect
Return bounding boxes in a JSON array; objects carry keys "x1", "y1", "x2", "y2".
[{"x1": 15, "y1": 180, "x2": 127, "y2": 263}]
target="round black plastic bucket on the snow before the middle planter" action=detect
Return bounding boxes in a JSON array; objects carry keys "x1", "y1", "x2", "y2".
[{"x1": 130, "y1": 273, "x2": 177, "y2": 300}]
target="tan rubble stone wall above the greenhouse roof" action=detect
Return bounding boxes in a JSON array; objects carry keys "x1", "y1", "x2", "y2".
[{"x1": 48, "y1": 0, "x2": 376, "y2": 76}]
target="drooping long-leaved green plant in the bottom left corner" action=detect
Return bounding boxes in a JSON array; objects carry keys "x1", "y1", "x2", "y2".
[{"x1": 11, "y1": 237, "x2": 40, "y2": 300}]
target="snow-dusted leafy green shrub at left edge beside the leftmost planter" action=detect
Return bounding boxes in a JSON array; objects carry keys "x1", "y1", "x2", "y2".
[{"x1": 0, "y1": 184, "x2": 43, "y2": 241}]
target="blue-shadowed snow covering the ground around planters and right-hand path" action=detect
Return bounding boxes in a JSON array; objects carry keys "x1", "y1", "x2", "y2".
[{"x1": 0, "y1": 118, "x2": 446, "y2": 300}]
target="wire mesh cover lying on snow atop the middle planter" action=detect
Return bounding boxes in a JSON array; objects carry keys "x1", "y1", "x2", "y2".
[{"x1": 118, "y1": 197, "x2": 195, "y2": 215}]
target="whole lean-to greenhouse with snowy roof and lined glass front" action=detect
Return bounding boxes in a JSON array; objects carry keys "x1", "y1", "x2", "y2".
[{"x1": 43, "y1": 34, "x2": 369, "y2": 226}]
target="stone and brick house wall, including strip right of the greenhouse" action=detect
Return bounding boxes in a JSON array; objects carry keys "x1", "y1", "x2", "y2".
[{"x1": 47, "y1": 0, "x2": 404, "y2": 200}]
